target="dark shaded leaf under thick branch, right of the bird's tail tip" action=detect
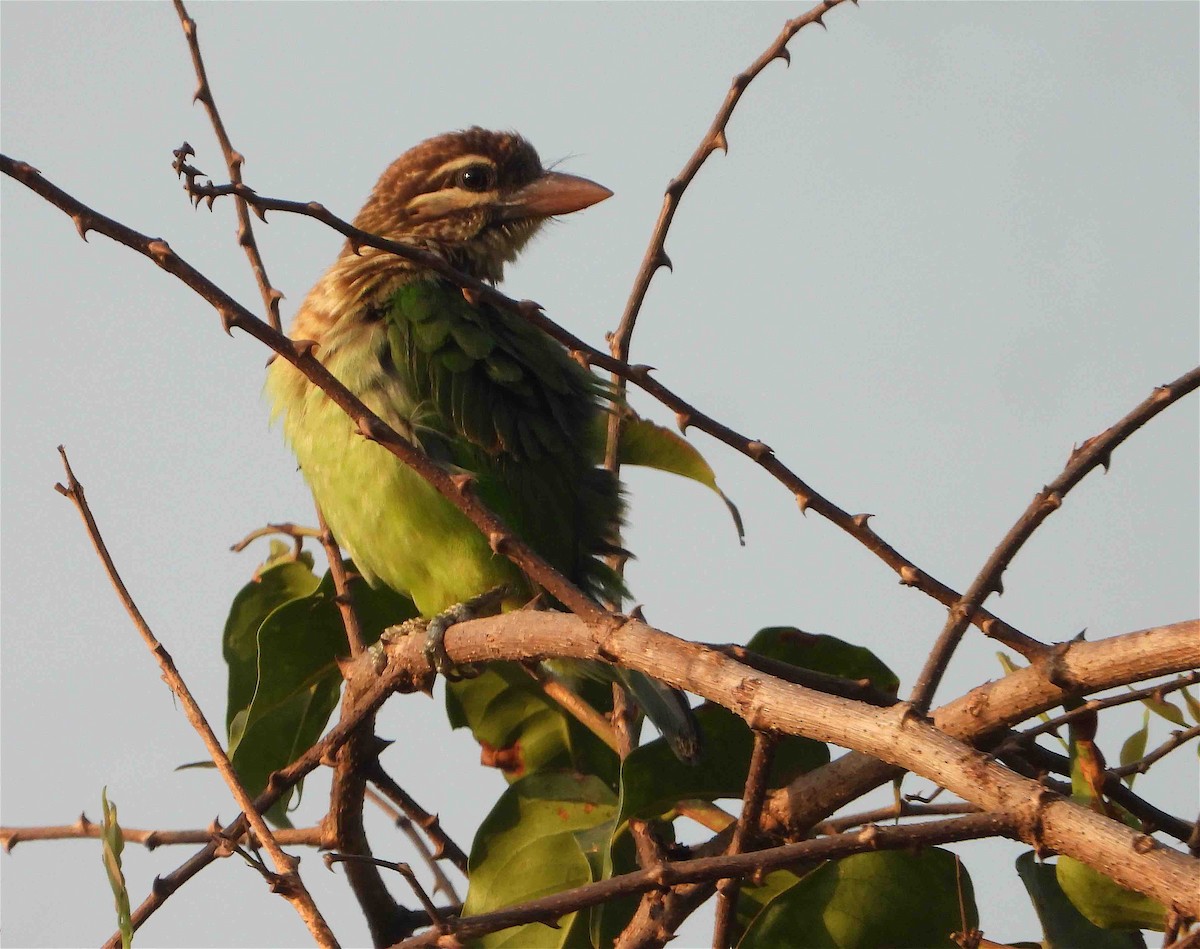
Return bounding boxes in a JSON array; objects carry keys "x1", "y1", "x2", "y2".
[{"x1": 620, "y1": 704, "x2": 829, "y2": 822}]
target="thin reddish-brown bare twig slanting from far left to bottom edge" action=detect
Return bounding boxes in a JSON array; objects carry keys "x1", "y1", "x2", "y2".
[{"x1": 54, "y1": 445, "x2": 337, "y2": 945}]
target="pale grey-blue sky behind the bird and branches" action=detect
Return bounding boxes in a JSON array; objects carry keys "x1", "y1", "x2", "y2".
[{"x1": 0, "y1": 2, "x2": 1200, "y2": 945}]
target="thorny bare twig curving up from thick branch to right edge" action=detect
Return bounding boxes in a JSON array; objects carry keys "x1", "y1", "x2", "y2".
[{"x1": 911, "y1": 367, "x2": 1200, "y2": 711}]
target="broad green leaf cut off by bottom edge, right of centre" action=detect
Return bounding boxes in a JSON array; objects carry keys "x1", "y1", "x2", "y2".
[{"x1": 738, "y1": 848, "x2": 979, "y2": 949}]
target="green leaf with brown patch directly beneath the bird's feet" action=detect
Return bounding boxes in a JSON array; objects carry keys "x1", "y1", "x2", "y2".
[{"x1": 446, "y1": 662, "x2": 618, "y2": 787}]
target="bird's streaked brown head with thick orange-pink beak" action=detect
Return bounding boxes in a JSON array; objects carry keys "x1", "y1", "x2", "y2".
[{"x1": 354, "y1": 128, "x2": 612, "y2": 281}]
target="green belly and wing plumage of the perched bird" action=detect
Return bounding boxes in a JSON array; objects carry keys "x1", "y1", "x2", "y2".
[{"x1": 269, "y1": 280, "x2": 622, "y2": 615}]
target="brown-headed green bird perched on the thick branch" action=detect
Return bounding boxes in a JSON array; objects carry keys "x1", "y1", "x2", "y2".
[{"x1": 266, "y1": 127, "x2": 700, "y2": 762}]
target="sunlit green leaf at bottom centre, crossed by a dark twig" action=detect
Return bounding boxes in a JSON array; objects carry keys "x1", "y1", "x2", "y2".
[{"x1": 463, "y1": 773, "x2": 617, "y2": 949}]
